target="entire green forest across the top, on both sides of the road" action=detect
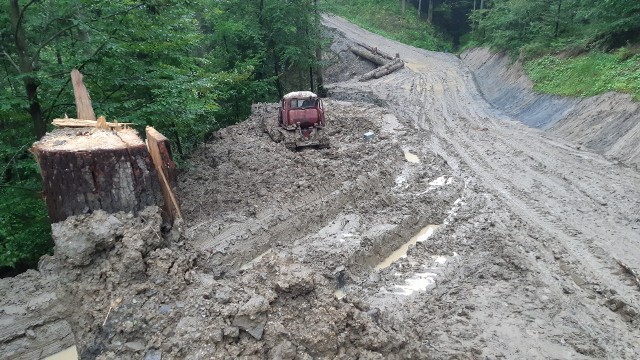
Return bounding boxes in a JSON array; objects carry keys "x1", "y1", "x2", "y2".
[{"x1": 0, "y1": 0, "x2": 640, "y2": 274}]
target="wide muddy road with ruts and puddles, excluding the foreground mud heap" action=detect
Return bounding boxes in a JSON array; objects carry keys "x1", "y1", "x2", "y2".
[{"x1": 183, "y1": 16, "x2": 640, "y2": 359}]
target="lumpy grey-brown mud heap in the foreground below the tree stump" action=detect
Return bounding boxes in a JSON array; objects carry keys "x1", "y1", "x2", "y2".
[{"x1": 45, "y1": 207, "x2": 421, "y2": 359}]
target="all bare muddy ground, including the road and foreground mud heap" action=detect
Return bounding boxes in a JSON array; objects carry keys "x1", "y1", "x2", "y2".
[{"x1": 0, "y1": 16, "x2": 640, "y2": 360}]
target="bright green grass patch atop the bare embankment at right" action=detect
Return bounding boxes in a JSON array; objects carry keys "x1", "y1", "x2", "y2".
[{"x1": 525, "y1": 49, "x2": 640, "y2": 101}]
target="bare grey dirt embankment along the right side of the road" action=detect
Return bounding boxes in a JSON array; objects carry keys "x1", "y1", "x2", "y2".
[{"x1": 461, "y1": 48, "x2": 640, "y2": 167}]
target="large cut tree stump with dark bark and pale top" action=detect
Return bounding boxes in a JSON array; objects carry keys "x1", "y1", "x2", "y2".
[{"x1": 31, "y1": 128, "x2": 163, "y2": 223}]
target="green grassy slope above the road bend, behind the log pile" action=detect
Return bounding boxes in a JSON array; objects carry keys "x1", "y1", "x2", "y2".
[{"x1": 321, "y1": 0, "x2": 452, "y2": 51}]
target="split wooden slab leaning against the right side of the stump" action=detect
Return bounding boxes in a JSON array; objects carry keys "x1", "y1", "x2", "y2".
[{"x1": 146, "y1": 126, "x2": 182, "y2": 224}]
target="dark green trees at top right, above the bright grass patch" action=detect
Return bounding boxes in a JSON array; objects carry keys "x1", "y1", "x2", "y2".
[{"x1": 471, "y1": 0, "x2": 640, "y2": 57}]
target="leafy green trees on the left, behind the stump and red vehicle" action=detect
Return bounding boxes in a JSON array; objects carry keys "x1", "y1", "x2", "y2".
[{"x1": 0, "y1": 0, "x2": 322, "y2": 272}]
